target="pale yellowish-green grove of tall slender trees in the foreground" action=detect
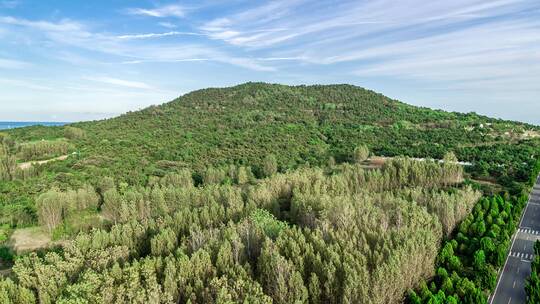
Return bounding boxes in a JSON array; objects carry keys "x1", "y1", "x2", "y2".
[{"x1": 2, "y1": 159, "x2": 480, "y2": 303}]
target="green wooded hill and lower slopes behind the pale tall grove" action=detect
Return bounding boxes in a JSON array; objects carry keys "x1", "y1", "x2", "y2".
[{"x1": 0, "y1": 83, "x2": 540, "y2": 225}]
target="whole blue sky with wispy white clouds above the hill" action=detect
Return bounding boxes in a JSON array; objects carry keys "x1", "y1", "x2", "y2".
[{"x1": 0, "y1": 0, "x2": 540, "y2": 124}]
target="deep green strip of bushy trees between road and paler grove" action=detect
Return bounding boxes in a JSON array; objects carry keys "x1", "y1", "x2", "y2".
[{"x1": 408, "y1": 195, "x2": 536, "y2": 303}]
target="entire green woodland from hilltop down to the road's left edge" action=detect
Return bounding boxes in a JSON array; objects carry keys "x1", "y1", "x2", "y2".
[{"x1": 0, "y1": 83, "x2": 540, "y2": 304}]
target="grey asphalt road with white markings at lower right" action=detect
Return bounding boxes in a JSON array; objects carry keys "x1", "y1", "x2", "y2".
[{"x1": 490, "y1": 179, "x2": 540, "y2": 304}]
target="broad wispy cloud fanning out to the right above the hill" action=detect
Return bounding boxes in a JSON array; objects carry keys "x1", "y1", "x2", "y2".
[{"x1": 200, "y1": 0, "x2": 540, "y2": 83}]
